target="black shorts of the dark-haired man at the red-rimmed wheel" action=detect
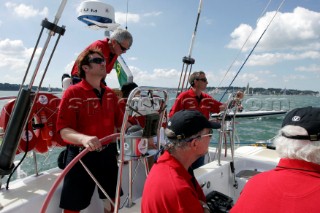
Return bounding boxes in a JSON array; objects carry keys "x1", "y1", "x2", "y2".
[{"x1": 60, "y1": 144, "x2": 118, "y2": 211}]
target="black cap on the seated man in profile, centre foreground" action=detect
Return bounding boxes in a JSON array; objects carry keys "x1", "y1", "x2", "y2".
[{"x1": 167, "y1": 110, "x2": 221, "y2": 139}]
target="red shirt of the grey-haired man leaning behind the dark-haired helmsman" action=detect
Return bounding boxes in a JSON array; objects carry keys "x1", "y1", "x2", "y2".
[{"x1": 71, "y1": 38, "x2": 118, "y2": 76}]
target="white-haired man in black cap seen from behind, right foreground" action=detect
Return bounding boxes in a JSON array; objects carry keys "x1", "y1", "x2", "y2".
[{"x1": 231, "y1": 107, "x2": 320, "y2": 213}]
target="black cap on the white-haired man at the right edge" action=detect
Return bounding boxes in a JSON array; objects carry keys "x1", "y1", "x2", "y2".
[{"x1": 282, "y1": 106, "x2": 320, "y2": 141}]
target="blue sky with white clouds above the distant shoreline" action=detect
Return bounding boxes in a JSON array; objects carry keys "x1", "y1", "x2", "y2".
[{"x1": 0, "y1": 0, "x2": 320, "y2": 91}]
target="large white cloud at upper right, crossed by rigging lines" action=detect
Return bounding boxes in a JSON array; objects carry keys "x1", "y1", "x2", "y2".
[{"x1": 227, "y1": 7, "x2": 320, "y2": 51}]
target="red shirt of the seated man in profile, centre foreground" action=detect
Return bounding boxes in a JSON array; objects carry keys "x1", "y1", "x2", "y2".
[{"x1": 141, "y1": 151, "x2": 205, "y2": 213}]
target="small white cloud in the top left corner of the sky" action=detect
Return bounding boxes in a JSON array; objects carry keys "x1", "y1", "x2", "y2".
[{"x1": 5, "y1": 2, "x2": 48, "y2": 18}]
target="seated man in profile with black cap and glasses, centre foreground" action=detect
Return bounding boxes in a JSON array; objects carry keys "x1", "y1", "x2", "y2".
[{"x1": 141, "y1": 110, "x2": 220, "y2": 213}]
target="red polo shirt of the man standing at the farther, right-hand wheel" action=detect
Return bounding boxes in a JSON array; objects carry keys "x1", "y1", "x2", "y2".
[{"x1": 169, "y1": 88, "x2": 222, "y2": 119}]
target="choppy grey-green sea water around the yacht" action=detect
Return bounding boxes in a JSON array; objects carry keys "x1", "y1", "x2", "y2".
[{"x1": 0, "y1": 91, "x2": 320, "y2": 184}]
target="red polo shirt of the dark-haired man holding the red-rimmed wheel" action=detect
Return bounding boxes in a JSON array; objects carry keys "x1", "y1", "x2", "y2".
[{"x1": 57, "y1": 80, "x2": 123, "y2": 142}]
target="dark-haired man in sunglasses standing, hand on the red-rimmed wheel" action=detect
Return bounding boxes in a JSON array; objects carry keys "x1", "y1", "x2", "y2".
[{"x1": 57, "y1": 48, "x2": 123, "y2": 213}]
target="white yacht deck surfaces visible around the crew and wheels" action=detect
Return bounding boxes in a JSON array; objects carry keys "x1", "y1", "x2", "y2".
[{"x1": 0, "y1": 146, "x2": 279, "y2": 213}]
